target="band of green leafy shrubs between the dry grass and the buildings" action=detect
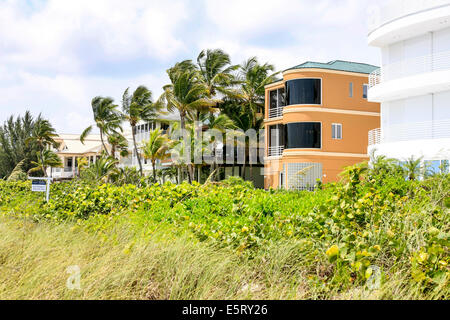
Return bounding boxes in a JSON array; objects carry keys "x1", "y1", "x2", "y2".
[{"x1": 2, "y1": 161, "x2": 450, "y2": 298}]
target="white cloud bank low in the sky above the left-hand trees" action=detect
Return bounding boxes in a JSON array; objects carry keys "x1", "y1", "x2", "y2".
[{"x1": 0, "y1": 67, "x2": 169, "y2": 133}]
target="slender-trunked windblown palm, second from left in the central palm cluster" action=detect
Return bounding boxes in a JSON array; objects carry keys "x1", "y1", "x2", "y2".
[{"x1": 122, "y1": 86, "x2": 163, "y2": 176}]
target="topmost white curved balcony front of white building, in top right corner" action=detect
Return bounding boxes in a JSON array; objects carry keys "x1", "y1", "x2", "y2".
[{"x1": 368, "y1": 0, "x2": 450, "y2": 34}]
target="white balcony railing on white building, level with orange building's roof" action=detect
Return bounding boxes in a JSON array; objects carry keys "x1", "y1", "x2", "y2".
[{"x1": 369, "y1": 51, "x2": 450, "y2": 88}]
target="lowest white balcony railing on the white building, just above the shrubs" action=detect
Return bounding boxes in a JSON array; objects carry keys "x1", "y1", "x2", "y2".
[{"x1": 369, "y1": 119, "x2": 450, "y2": 145}]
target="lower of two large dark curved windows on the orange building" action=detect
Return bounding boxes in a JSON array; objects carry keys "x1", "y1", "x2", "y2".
[{"x1": 284, "y1": 122, "x2": 322, "y2": 149}]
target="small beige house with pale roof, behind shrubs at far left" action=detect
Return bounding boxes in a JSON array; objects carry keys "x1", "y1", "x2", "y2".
[{"x1": 49, "y1": 134, "x2": 103, "y2": 179}]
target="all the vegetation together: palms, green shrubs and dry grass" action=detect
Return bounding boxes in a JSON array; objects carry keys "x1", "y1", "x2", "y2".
[{"x1": 0, "y1": 50, "x2": 450, "y2": 300}]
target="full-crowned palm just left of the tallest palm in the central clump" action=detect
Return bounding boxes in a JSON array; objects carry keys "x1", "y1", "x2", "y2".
[{"x1": 161, "y1": 67, "x2": 215, "y2": 183}]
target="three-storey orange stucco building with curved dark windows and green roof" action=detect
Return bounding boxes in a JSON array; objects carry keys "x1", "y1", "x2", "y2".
[{"x1": 265, "y1": 61, "x2": 380, "y2": 190}]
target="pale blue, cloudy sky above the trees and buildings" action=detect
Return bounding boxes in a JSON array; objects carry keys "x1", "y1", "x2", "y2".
[{"x1": 0, "y1": 0, "x2": 381, "y2": 133}]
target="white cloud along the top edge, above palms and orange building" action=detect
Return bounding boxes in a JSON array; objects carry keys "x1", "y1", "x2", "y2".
[{"x1": 204, "y1": 0, "x2": 364, "y2": 35}]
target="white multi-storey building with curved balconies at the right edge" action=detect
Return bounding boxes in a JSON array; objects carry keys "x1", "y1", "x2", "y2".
[{"x1": 368, "y1": 0, "x2": 450, "y2": 169}]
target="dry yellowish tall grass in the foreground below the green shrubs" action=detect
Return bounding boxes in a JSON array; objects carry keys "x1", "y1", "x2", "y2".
[{"x1": 0, "y1": 217, "x2": 442, "y2": 300}]
